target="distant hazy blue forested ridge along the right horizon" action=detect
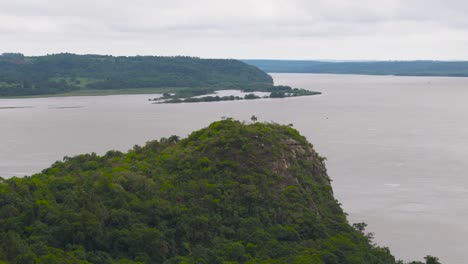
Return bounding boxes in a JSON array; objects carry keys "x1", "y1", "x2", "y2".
[{"x1": 244, "y1": 60, "x2": 468, "y2": 77}]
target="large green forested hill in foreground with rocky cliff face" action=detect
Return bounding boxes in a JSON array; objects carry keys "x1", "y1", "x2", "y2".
[{"x1": 0, "y1": 119, "x2": 438, "y2": 264}]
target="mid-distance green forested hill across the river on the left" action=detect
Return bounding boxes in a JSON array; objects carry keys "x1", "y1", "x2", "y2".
[{"x1": 0, "y1": 53, "x2": 273, "y2": 96}]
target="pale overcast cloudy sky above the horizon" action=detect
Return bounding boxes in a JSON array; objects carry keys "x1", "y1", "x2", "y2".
[{"x1": 0, "y1": 0, "x2": 468, "y2": 60}]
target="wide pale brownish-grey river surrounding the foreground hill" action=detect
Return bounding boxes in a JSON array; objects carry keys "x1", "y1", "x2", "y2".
[{"x1": 0, "y1": 74, "x2": 468, "y2": 264}]
